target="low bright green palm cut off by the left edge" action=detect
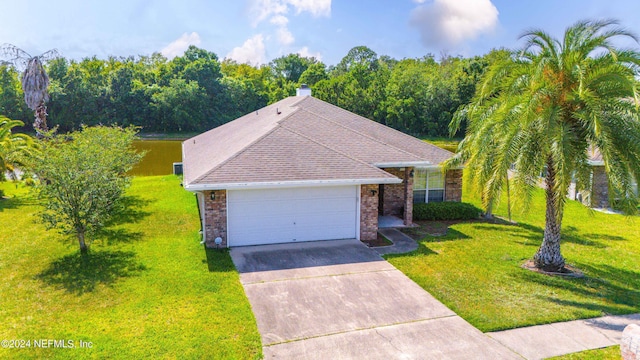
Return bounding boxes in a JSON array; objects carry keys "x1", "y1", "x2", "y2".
[{"x1": 0, "y1": 115, "x2": 34, "y2": 179}]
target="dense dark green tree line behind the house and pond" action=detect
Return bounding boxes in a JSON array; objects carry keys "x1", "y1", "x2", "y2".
[{"x1": 0, "y1": 46, "x2": 500, "y2": 137}]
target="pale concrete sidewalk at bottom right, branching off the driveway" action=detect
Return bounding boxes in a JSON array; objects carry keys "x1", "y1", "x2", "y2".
[{"x1": 486, "y1": 314, "x2": 640, "y2": 360}]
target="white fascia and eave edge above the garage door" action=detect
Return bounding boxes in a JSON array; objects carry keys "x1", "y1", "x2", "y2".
[{"x1": 184, "y1": 178, "x2": 402, "y2": 192}]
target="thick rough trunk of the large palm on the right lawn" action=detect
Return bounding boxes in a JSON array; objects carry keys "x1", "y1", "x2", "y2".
[{"x1": 533, "y1": 161, "x2": 564, "y2": 272}]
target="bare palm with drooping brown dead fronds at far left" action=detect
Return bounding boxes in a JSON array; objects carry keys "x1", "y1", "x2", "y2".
[{"x1": 0, "y1": 44, "x2": 58, "y2": 137}]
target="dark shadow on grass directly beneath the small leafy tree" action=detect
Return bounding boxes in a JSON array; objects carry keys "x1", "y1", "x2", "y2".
[{"x1": 36, "y1": 250, "x2": 146, "y2": 295}]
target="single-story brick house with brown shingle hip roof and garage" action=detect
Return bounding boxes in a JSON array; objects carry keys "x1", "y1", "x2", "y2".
[{"x1": 182, "y1": 87, "x2": 462, "y2": 247}]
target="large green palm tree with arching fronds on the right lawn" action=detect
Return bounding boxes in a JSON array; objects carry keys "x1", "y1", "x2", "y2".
[{"x1": 449, "y1": 20, "x2": 640, "y2": 271}]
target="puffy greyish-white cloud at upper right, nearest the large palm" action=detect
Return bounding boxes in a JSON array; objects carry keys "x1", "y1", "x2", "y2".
[{"x1": 410, "y1": 0, "x2": 498, "y2": 47}]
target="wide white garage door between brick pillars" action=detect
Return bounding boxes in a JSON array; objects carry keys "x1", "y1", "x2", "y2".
[{"x1": 227, "y1": 186, "x2": 358, "y2": 246}]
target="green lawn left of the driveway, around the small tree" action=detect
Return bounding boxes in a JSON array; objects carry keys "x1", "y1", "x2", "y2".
[{"x1": 0, "y1": 176, "x2": 262, "y2": 359}]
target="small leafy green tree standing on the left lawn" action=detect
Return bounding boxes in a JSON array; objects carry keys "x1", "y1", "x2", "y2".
[{"x1": 34, "y1": 126, "x2": 144, "y2": 254}]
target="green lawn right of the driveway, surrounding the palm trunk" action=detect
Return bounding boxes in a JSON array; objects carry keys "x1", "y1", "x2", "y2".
[{"x1": 386, "y1": 189, "x2": 640, "y2": 331}]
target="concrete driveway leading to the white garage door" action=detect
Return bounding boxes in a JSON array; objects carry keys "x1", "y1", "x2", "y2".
[{"x1": 231, "y1": 240, "x2": 521, "y2": 359}]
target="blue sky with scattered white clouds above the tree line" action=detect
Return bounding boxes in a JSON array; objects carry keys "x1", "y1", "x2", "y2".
[{"x1": 0, "y1": 0, "x2": 640, "y2": 65}]
